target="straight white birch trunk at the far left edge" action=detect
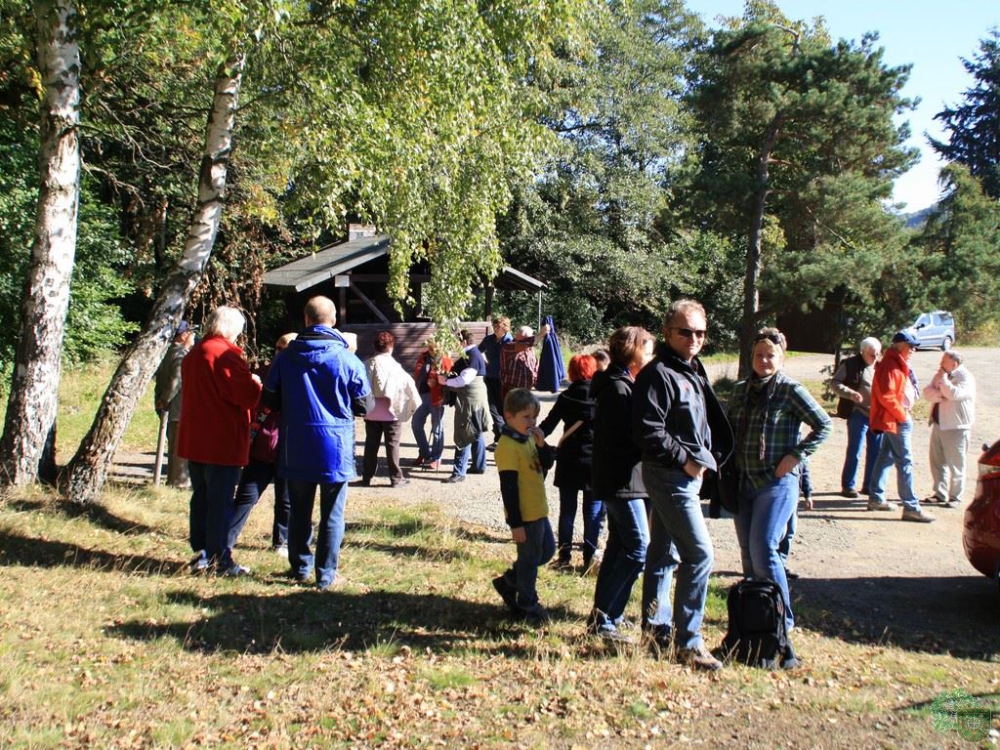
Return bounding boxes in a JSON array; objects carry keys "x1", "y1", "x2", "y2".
[{"x1": 0, "y1": 0, "x2": 80, "y2": 486}]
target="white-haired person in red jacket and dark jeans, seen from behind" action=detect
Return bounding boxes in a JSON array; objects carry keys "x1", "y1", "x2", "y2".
[{"x1": 178, "y1": 307, "x2": 261, "y2": 576}]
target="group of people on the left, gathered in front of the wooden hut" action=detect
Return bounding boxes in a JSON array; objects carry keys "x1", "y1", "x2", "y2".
[{"x1": 154, "y1": 297, "x2": 560, "y2": 589}]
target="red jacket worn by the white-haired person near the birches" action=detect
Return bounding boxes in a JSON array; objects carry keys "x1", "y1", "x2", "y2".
[{"x1": 177, "y1": 336, "x2": 261, "y2": 466}]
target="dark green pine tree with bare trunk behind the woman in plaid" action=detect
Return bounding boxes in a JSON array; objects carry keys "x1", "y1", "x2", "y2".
[{"x1": 686, "y1": 0, "x2": 914, "y2": 369}]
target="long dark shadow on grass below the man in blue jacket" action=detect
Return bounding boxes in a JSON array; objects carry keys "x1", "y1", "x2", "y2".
[{"x1": 105, "y1": 590, "x2": 560, "y2": 658}]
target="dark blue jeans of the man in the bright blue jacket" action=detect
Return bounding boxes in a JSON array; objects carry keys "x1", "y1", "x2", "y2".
[{"x1": 288, "y1": 479, "x2": 347, "y2": 589}]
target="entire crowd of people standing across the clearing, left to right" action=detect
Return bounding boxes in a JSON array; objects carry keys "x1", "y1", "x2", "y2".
[{"x1": 157, "y1": 297, "x2": 975, "y2": 670}]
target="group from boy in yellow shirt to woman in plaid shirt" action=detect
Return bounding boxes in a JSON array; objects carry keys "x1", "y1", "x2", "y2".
[{"x1": 493, "y1": 299, "x2": 832, "y2": 670}]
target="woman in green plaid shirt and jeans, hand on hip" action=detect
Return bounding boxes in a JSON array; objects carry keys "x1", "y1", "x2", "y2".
[{"x1": 729, "y1": 328, "x2": 832, "y2": 667}]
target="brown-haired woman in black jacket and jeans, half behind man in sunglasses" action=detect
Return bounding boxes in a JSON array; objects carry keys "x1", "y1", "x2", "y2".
[{"x1": 587, "y1": 326, "x2": 653, "y2": 641}]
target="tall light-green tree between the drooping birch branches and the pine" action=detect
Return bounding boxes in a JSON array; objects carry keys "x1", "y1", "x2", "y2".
[{"x1": 501, "y1": 0, "x2": 700, "y2": 341}]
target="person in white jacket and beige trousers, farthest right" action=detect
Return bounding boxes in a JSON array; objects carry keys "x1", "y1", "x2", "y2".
[{"x1": 924, "y1": 349, "x2": 976, "y2": 508}]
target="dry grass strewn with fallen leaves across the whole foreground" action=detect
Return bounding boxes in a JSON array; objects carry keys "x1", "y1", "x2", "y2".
[{"x1": 0, "y1": 489, "x2": 1000, "y2": 748}]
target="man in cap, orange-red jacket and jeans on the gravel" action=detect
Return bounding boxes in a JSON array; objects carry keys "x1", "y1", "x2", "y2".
[{"x1": 868, "y1": 331, "x2": 934, "y2": 523}]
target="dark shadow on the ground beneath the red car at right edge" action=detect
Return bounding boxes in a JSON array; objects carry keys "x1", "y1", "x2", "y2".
[{"x1": 792, "y1": 575, "x2": 1000, "y2": 661}]
